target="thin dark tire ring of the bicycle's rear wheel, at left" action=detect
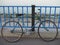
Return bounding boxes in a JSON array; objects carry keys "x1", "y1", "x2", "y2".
[{"x1": 1, "y1": 21, "x2": 23, "y2": 43}]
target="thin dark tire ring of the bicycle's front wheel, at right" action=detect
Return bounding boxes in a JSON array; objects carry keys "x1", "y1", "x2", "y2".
[{"x1": 38, "y1": 20, "x2": 58, "y2": 42}]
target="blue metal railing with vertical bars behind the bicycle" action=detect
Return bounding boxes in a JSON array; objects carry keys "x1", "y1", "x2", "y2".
[{"x1": 0, "y1": 5, "x2": 60, "y2": 28}]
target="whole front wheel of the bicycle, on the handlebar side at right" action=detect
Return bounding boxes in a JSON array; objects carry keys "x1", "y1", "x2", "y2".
[{"x1": 38, "y1": 20, "x2": 58, "y2": 42}]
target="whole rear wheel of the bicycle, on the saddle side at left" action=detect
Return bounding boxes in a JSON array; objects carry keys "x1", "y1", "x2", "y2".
[{"x1": 1, "y1": 21, "x2": 23, "y2": 43}]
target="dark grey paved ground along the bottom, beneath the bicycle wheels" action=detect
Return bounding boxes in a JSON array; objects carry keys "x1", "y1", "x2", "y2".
[{"x1": 0, "y1": 38, "x2": 60, "y2": 45}]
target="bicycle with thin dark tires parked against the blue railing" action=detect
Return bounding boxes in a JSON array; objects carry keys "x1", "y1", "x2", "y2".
[{"x1": 1, "y1": 9, "x2": 58, "y2": 43}]
